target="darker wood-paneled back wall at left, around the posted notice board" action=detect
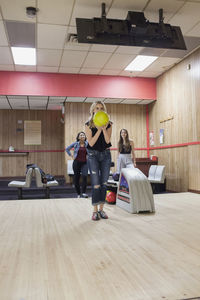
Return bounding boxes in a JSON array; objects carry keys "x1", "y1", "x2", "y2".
[{"x1": 0, "y1": 110, "x2": 64, "y2": 176}]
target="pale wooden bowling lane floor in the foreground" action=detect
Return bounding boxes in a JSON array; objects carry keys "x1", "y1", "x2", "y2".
[{"x1": 0, "y1": 193, "x2": 200, "y2": 300}]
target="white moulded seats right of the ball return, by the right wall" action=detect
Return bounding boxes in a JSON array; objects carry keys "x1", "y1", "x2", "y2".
[{"x1": 148, "y1": 165, "x2": 166, "y2": 194}]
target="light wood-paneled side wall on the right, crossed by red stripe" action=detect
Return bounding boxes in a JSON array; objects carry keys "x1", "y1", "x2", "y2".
[{"x1": 149, "y1": 49, "x2": 200, "y2": 192}]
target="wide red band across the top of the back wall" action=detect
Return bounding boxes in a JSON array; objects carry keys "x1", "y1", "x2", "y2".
[{"x1": 0, "y1": 71, "x2": 156, "y2": 99}]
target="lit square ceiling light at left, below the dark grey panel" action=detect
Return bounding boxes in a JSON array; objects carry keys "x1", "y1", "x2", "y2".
[{"x1": 11, "y1": 47, "x2": 36, "y2": 66}]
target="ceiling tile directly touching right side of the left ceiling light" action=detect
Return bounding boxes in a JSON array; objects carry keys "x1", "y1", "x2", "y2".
[{"x1": 37, "y1": 49, "x2": 62, "y2": 67}]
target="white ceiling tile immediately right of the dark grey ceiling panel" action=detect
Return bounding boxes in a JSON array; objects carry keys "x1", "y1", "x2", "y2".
[{"x1": 37, "y1": 24, "x2": 67, "y2": 49}]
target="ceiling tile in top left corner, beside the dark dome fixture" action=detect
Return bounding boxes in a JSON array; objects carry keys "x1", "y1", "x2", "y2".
[{"x1": 0, "y1": 0, "x2": 36, "y2": 22}]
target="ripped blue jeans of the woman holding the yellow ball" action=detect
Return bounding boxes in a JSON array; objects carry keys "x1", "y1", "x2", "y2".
[{"x1": 88, "y1": 149, "x2": 111, "y2": 206}]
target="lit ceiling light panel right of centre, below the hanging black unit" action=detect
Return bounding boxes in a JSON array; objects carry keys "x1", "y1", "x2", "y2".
[{"x1": 125, "y1": 55, "x2": 158, "y2": 71}]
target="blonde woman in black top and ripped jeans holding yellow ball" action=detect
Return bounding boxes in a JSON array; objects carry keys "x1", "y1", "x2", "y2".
[{"x1": 85, "y1": 101, "x2": 112, "y2": 221}]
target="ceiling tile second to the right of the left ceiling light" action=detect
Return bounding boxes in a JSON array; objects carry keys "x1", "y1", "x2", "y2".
[{"x1": 61, "y1": 50, "x2": 87, "y2": 68}]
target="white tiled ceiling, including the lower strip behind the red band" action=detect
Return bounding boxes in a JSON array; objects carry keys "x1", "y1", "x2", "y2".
[{"x1": 0, "y1": 0, "x2": 200, "y2": 109}]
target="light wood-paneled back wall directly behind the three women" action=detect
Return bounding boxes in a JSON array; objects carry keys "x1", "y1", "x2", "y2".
[{"x1": 65, "y1": 103, "x2": 147, "y2": 182}]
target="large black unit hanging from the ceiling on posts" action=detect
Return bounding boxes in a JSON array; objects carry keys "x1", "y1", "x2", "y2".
[{"x1": 76, "y1": 3, "x2": 187, "y2": 50}]
